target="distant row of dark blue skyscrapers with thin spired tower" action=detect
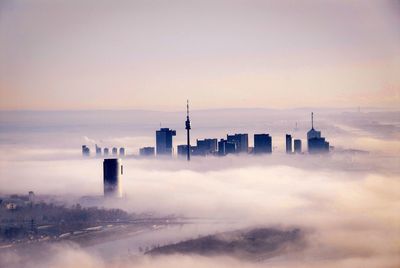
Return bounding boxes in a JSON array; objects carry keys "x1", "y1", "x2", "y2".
[{"x1": 82, "y1": 110, "x2": 328, "y2": 157}]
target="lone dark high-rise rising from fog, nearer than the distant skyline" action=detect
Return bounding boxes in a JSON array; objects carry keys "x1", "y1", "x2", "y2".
[{"x1": 103, "y1": 158, "x2": 123, "y2": 197}]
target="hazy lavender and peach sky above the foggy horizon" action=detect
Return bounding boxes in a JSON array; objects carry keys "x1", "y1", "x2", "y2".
[{"x1": 0, "y1": 0, "x2": 400, "y2": 111}]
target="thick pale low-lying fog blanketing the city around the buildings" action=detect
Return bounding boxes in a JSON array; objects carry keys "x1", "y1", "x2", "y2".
[{"x1": 0, "y1": 110, "x2": 400, "y2": 267}]
